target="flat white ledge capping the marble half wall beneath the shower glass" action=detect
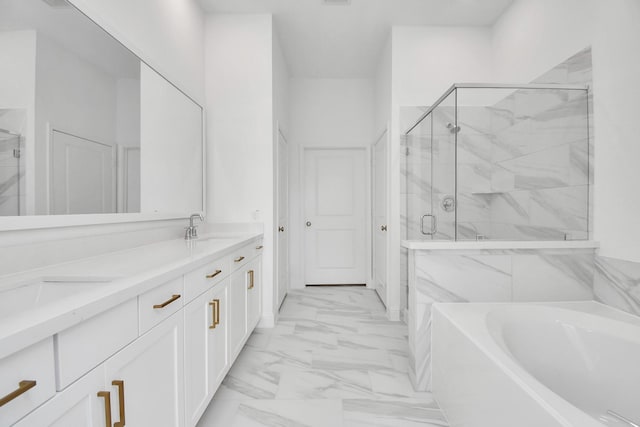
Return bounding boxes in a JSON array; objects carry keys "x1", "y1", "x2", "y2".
[{"x1": 402, "y1": 240, "x2": 600, "y2": 250}]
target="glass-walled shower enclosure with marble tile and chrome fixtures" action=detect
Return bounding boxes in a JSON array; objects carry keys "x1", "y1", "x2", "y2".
[{"x1": 403, "y1": 84, "x2": 590, "y2": 240}]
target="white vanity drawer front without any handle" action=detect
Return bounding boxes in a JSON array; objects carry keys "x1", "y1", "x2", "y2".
[{"x1": 55, "y1": 298, "x2": 138, "y2": 390}]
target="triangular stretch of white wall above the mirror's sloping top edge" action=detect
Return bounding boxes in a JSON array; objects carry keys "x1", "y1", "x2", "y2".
[{"x1": 70, "y1": 0, "x2": 204, "y2": 105}]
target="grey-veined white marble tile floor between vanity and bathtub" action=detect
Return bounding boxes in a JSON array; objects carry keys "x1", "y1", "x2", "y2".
[{"x1": 198, "y1": 287, "x2": 448, "y2": 427}]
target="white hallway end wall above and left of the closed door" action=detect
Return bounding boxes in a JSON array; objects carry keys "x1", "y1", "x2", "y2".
[{"x1": 289, "y1": 78, "x2": 375, "y2": 288}]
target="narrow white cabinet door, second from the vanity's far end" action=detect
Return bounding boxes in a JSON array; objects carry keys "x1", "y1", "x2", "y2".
[{"x1": 229, "y1": 267, "x2": 247, "y2": 360}]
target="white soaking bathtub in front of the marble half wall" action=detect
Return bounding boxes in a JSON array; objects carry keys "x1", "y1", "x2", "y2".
[{"x1": 432, "y1": 301, "x2": 640, "y2": 427}]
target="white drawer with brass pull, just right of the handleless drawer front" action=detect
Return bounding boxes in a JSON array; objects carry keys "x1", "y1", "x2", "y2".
[{"x1": 138, "y1": 276, "x2": 184, "y2": 335}]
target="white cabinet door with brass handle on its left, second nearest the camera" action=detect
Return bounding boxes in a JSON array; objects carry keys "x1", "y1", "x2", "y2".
[{"x1": 105, "y1": 312, "x2": 184, "y2": 427}]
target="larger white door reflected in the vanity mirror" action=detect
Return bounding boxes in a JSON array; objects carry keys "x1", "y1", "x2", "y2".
[{"x1": 49, "y1": 130, "x2": 116, "y2": 214}]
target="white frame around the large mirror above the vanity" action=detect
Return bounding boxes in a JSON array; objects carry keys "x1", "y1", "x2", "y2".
[{"x1": 0, "y1": 0, "x2": 207, "y2": 233}]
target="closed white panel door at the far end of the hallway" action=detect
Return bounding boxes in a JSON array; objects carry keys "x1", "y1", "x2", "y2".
[{"x1": 304, "y1": 149, "x2": 368, "y2": 285}]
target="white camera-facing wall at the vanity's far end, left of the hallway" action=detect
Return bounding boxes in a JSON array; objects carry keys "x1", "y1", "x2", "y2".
[{"x1": 205, "y1": 15, "x2": 275, "y2": 326}]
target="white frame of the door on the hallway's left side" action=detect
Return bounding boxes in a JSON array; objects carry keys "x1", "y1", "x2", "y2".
[{"x1": 273, "y1": 122, "x2": 291, "y2": 310}]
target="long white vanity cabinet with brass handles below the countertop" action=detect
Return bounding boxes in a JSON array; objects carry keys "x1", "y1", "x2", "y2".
[{"x1": 0, "y1": 242, "x2": 261, "y2": 427}]
